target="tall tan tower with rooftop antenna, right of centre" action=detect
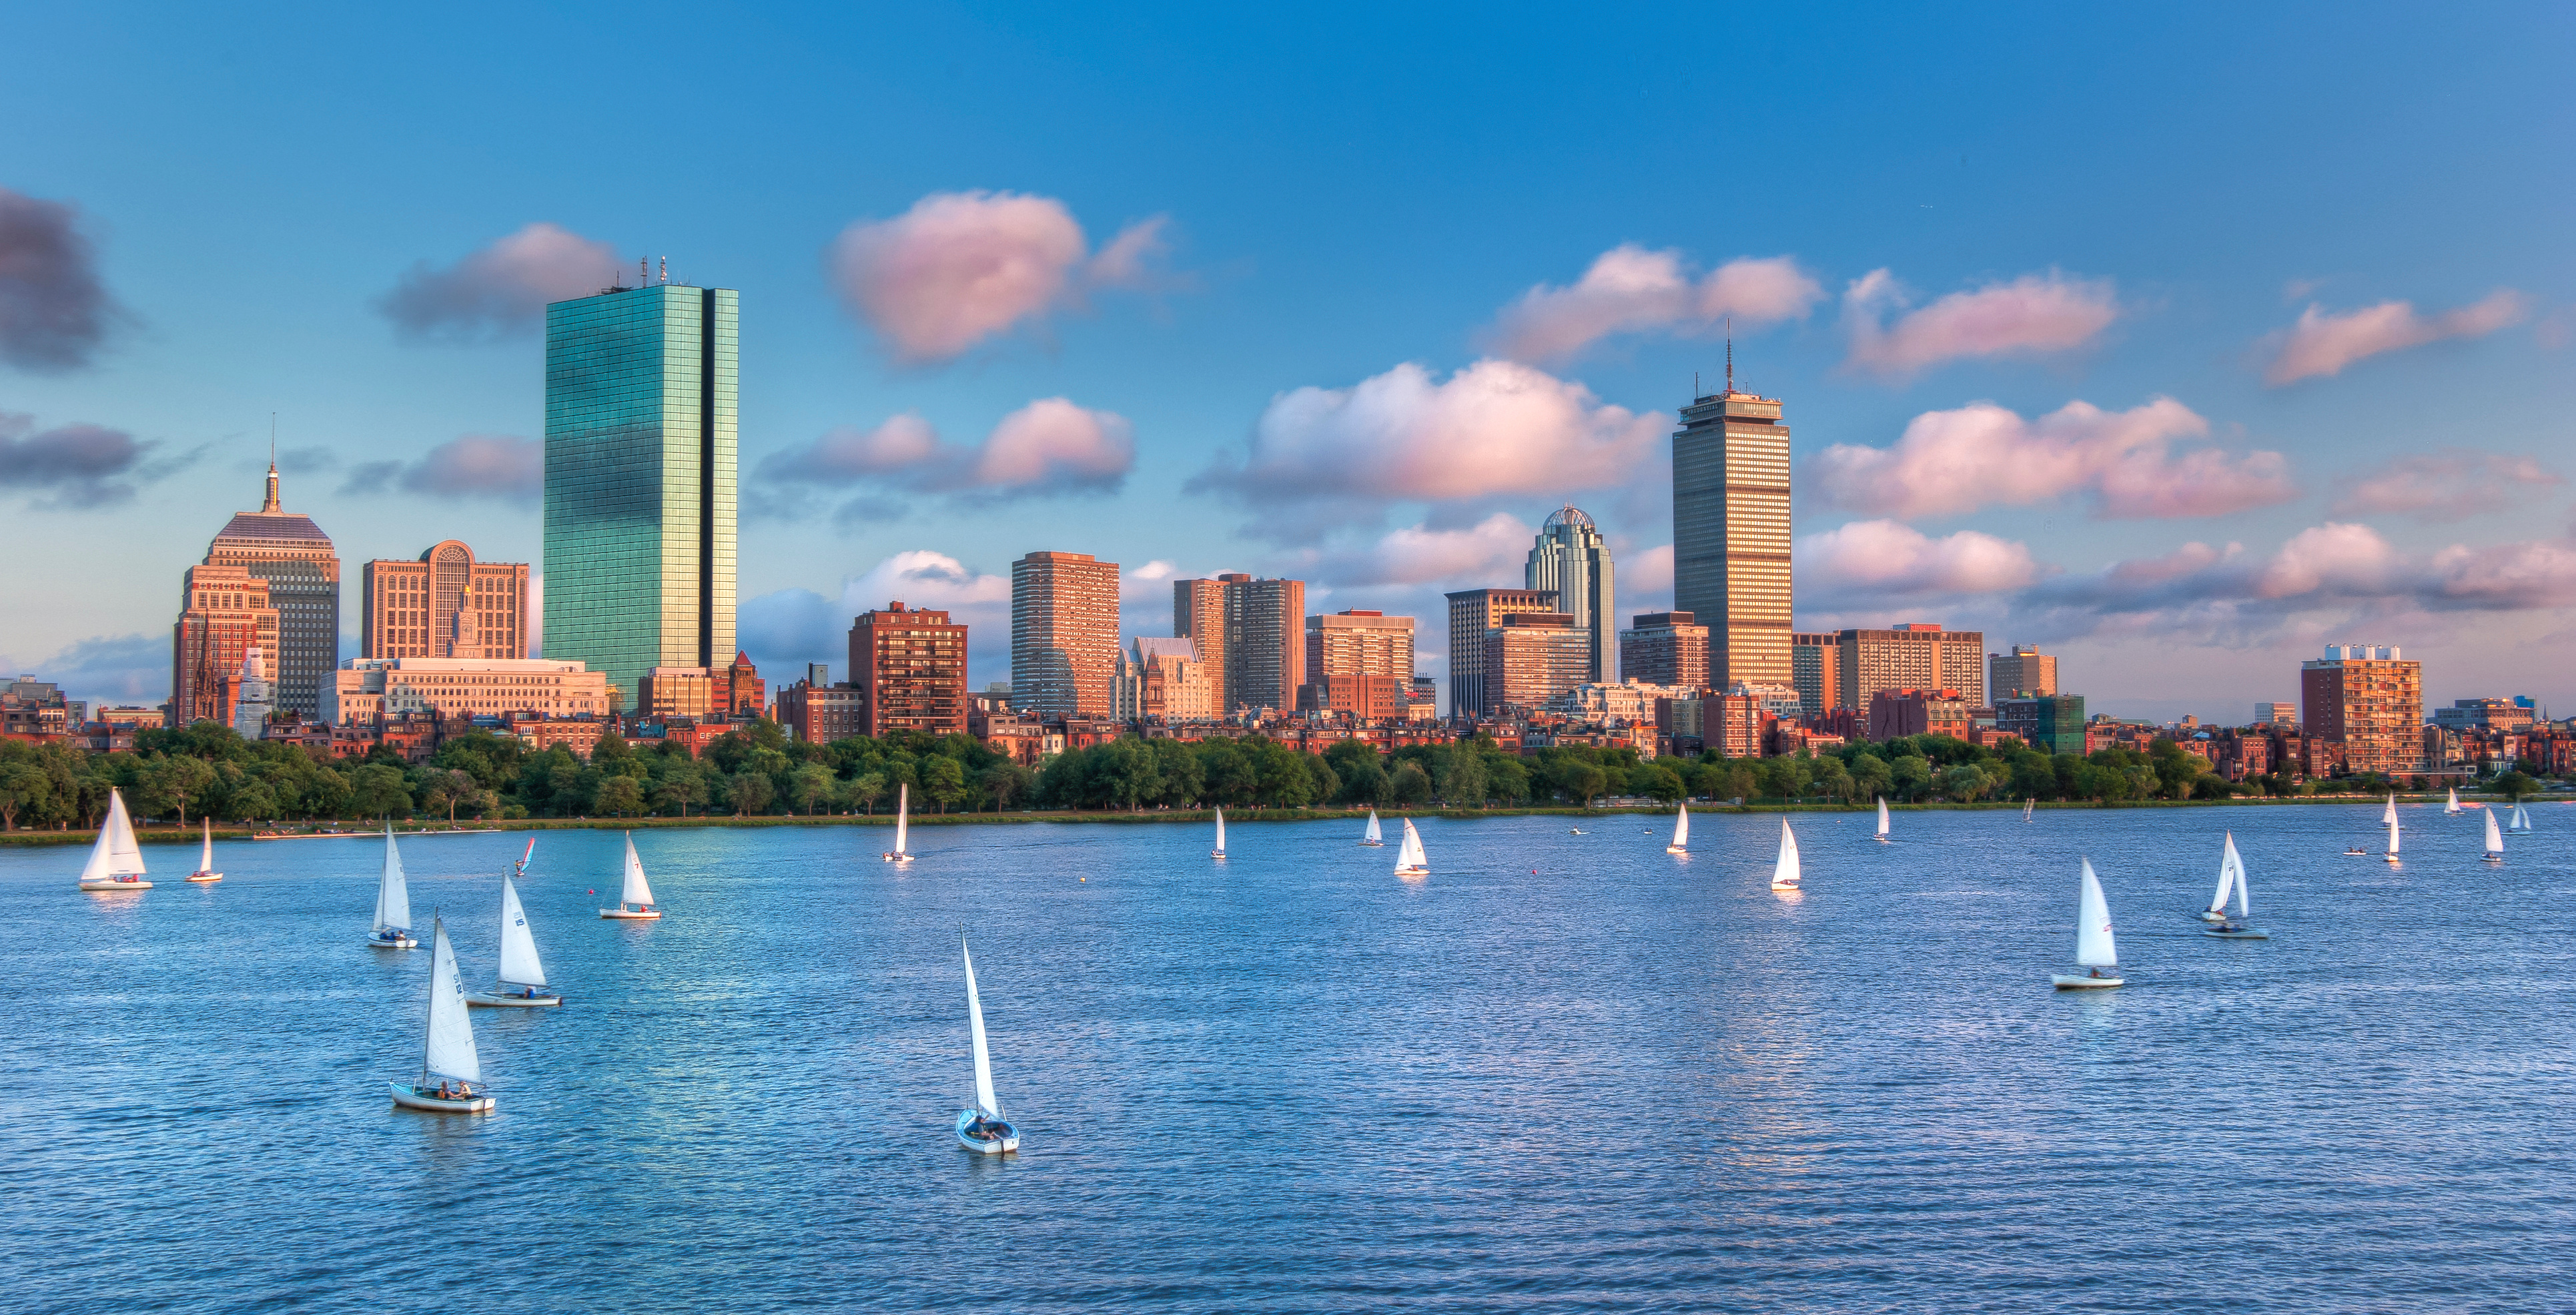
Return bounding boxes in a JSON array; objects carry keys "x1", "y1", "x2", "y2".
[{"x1": 1672, "y1": 361, "x2": 1790, "y2": 686}]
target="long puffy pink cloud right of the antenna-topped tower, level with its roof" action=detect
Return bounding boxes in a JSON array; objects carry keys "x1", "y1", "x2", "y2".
[{"x1": 1808, "y1": 397, "x2": 2298, "y2": 518}]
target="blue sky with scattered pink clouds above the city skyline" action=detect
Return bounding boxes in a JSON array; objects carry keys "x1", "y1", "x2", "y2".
[{"x1": 0, "y1": 5, "x2": 2576, "y2": 719}]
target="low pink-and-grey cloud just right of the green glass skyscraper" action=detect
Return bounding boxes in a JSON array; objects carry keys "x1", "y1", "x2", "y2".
[{"x1": 755, "y1": 397, "x2": 1136, "y2": 502}]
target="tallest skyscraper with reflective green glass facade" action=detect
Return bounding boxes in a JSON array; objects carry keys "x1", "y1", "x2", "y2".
[{"x1": 544, "y1": 284, "x2": 739, "y2": 699}]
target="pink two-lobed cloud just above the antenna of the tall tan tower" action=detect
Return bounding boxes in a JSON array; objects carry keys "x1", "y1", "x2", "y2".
[{"x1": 1486, "y1": 242, "x2": 1824, "y2": 364}]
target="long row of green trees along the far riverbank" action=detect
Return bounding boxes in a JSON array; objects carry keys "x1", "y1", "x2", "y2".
[{"x1": 0, "y1": 722, "x2": 2540, "y2": 843}]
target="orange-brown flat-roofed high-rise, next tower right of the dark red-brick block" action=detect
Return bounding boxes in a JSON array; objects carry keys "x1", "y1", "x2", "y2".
[{"x1": 1009, "y1": 552, "x2": 1118, "y2": 722}]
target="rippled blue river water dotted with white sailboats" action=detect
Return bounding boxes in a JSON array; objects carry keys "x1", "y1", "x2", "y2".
[{"x1": 0, "y1": 805, "x2": 2576, "y2": 1310}]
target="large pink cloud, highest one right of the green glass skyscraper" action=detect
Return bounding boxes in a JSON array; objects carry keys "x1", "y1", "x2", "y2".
[{"x1": 825, "y1": 191, "x2": 1164, "y2": 364}]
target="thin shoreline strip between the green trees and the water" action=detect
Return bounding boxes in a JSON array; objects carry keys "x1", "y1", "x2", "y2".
[{"x1": 0, "y1": 794, "x2": 2535, "y2": 848}]
